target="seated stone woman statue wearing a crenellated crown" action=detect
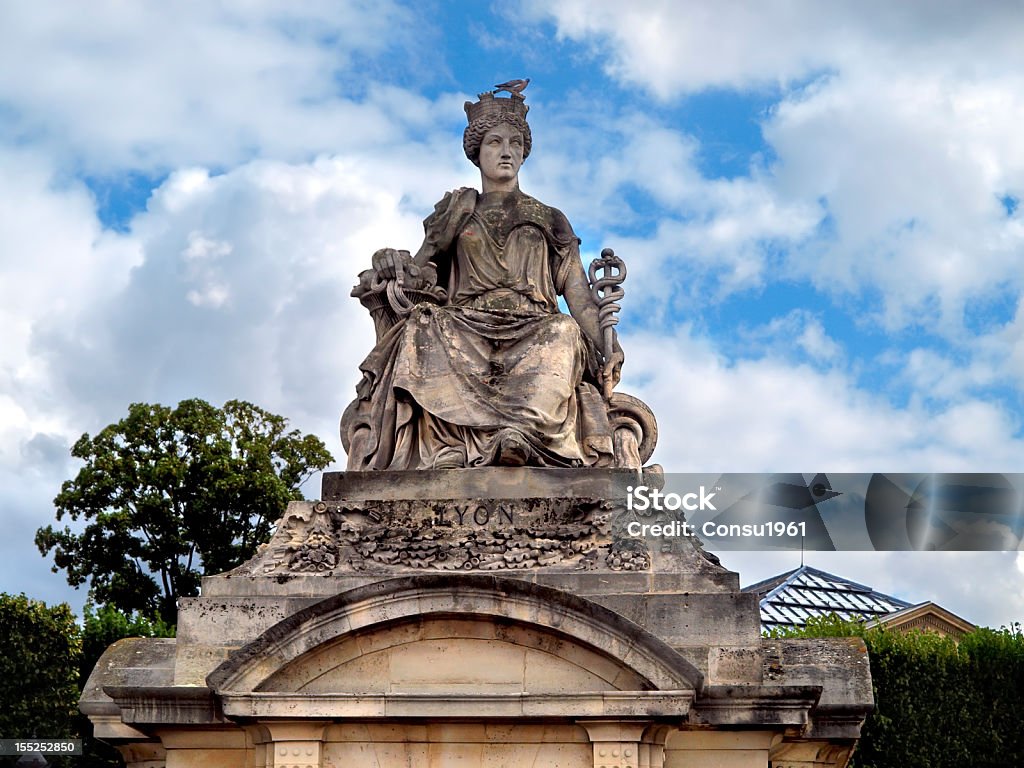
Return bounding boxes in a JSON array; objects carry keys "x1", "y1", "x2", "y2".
[{"x1": 341, "y1": 88, "x2": 623, "y2": 470}]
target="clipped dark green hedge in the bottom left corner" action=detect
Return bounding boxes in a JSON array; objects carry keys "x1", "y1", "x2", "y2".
[{"x1": 0, "y1": 593, "x2": 82, "y2": 753}]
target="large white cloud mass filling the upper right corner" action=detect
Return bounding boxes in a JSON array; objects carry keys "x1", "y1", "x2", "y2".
[{"x1": 528, "y1": 0, "x2": 1024, "y2": 339}]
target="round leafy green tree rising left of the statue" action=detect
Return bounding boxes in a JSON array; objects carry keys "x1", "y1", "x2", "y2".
[{"x1": 36, "y1": 399, "x2": 333, "y2": 625}]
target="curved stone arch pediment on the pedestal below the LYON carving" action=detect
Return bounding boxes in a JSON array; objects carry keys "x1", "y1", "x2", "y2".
[{"x1": 207, "y1": 574, "x2": 703, "y2": 697}]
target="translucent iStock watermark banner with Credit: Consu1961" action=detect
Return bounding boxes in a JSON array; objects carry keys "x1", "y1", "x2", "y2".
[{"x1": 620, "y1": 472, "x2": 1024, "y2": 551}]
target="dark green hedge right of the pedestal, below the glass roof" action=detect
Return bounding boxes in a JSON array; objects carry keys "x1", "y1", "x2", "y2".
[{"x1": 776, "y1": 615, "x2": 1024, "y2": 768}]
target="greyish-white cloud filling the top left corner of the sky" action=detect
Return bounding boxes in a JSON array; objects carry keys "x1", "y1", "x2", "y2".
[{"x1": 0, "y1": 0, "x2": 429, "y2": 173}]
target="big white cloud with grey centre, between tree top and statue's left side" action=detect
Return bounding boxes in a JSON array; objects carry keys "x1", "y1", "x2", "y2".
[{"x1": 9, "y1": 108, "x2": 467, "y2": 457}]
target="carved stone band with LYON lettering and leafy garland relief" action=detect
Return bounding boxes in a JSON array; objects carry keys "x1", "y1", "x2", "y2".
[{"x1": 243, "y1": 499, "x2": 650, "y2": 573}]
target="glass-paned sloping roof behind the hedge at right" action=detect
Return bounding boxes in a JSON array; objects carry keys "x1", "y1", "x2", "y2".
[{"x1": 742, "y1": 565, "x2": 911, "y2": 631}]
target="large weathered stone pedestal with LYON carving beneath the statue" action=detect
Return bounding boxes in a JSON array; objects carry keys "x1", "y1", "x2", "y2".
[{"x1": 81, "y1": 468, "x2": 871, "y2": 768}]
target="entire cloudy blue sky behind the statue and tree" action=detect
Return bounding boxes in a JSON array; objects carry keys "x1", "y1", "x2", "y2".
[{"x1": 0, "y1": 0, "x2": 1024, "y2": 626}]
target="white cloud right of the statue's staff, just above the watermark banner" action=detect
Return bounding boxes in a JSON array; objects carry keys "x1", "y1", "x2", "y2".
[{"x1": 623, "y1": 329, "x2": 1024, "y2": 472}]
